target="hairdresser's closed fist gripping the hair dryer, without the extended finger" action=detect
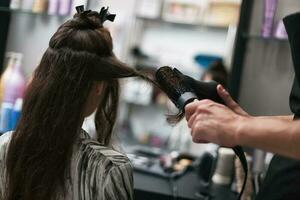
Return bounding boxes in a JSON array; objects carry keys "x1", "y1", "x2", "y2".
[{"x1": 185, "y1": 98, "x2": 249, "y2": 147}]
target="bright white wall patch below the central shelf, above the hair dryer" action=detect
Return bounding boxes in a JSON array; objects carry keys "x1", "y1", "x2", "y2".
[{"x1": 142, "y1": 24, "x2": 228, "y2": 77}]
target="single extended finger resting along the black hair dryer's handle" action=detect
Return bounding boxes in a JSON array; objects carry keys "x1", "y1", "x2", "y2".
[{"x1": 217, "y1": 84, "x2": 249, "y2": 116}]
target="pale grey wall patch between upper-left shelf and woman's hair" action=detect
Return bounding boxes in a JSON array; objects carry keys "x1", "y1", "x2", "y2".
[{"x1": 6, "y1": 13, "x2": 65, "y2": 77}]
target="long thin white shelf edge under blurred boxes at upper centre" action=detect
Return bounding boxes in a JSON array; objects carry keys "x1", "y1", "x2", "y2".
[{"x1": 136, "y1": 16, "x2": 228, "y2": 31}]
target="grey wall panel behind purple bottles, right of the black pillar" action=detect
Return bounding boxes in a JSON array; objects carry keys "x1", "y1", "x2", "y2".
[{"x1": 239, "y1": 0, "x2": 300, "y2": 115}]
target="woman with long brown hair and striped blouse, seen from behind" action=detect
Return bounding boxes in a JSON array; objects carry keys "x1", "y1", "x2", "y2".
[{"x1": 0, "y1": 7, "x2": 147, "y2": 200}]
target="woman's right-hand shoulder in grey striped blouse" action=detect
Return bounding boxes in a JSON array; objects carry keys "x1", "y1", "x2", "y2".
[{"x1": 73, "y1": 132, "x2": 133, "y2": 200}]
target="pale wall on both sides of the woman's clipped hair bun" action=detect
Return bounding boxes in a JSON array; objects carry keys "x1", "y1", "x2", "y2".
[{"x1": 6, "y1": 0, "x2": 135, "y2": 77}]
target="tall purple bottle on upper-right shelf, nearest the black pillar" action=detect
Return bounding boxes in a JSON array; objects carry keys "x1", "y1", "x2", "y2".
[{"x1": 261, "y1": 0, "x2": 278, "y2": 38}]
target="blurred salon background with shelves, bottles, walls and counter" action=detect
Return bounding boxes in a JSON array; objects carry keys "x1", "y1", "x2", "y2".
[{"x1": 0, "y1": 0, "x2": 300, "y2": 199}]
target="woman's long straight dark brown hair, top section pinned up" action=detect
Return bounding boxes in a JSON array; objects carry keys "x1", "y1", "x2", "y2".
[{"x1": 5, "y1": 12, "x2": 151, "y2": 200}]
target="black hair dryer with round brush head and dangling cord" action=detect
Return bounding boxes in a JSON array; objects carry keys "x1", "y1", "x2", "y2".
[{"x1": 155, "y1": 66, "x2": 248, "y2": 199}]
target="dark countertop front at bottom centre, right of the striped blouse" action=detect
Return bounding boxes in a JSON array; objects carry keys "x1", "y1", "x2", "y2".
[{"x1": 134, "y1": 168, "x2": 236, "y2": 200}]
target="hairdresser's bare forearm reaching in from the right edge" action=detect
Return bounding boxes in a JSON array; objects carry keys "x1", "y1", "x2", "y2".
[{"x1": 236, "y1": 116, "x2": 300, "y2": 159}]
